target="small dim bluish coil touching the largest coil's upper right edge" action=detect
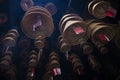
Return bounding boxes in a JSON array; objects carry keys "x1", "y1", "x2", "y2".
[{"x1": 45, "y1": 2, "x2": 57, "y2": 15}]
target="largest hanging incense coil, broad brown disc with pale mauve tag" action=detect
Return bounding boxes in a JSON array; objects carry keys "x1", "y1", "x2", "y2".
[{"x1": 21, "y1": 6, "x2": 54, "y2": 39}]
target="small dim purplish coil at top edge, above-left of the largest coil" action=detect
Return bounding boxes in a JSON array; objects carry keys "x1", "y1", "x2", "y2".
[{"x1": 20, "y1": 0, "x2": 34, "y2": 11}]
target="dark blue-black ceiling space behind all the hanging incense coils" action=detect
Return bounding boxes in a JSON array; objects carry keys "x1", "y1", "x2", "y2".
[{"x1": 0, "y1": 0, "x2": 120, "y2": 80}]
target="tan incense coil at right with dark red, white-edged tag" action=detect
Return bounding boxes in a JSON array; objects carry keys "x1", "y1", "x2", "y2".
[{"x1": 87, "y1": 20, "x2": 115, "y2": 45}]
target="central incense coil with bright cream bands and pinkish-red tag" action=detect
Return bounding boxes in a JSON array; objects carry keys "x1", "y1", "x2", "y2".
[{"x1": 59, "y1": 14, "x2": 88, "y2": 45}]
